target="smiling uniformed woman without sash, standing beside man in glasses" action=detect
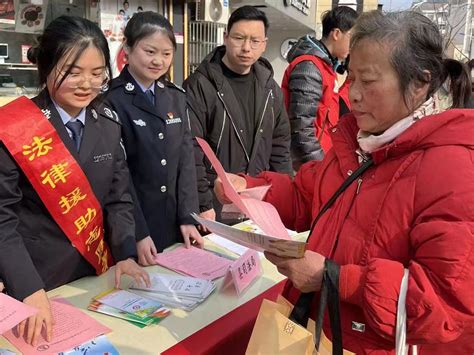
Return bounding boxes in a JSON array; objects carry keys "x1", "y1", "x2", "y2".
[{"x1": 107, "y1": 12, "x2": 202, "y2": 265}]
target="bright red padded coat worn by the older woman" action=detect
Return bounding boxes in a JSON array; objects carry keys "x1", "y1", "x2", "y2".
[{"x1": 246, "y1": 110, "x2": 474, "y2": 354}]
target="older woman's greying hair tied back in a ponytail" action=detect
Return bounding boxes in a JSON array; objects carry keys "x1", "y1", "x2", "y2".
[{"x1": 351, "y1": 11, "x2": 471, "y2": 107}]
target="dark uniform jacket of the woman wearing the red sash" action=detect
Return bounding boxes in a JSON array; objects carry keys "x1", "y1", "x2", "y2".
[{"x1": 0, "y1": 90, "x2": 136, "y2": 300}]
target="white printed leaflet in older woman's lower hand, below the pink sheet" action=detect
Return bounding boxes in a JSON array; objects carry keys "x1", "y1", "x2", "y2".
[{"x1": 191, "y1": 213, "x2": 306, "y2": 258}]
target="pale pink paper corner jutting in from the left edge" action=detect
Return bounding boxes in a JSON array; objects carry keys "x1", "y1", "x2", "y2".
[{"x1": 0, "y1": 292, "x2": 38, "y2": 334}]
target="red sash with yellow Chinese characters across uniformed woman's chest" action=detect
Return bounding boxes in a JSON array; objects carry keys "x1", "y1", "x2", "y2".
[{"x1": 0, "y1": 97, "x2": 113, "y2": 275}]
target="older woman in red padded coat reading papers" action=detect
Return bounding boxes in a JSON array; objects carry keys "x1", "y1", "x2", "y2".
[{"x1": 215, "y1": 12, "x2": 474, "y2": 354}]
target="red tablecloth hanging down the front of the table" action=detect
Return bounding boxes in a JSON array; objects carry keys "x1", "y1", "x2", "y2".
[{"x1": 162, "y1": 280, "x2": 286, "y2": 355}]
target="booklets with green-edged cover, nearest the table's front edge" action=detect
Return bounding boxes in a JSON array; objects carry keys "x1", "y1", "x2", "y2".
[{"x1": 88, "y1": 289, "x2": 170, "y2": 328}]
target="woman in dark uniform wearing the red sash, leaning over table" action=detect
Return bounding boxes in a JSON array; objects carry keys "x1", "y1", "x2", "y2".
[{"x1": 0, "y1": 16, "x2": 149, "y2": 345}]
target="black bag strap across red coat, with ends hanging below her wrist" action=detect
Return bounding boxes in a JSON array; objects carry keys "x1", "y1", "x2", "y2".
[{"x1": 290, "y1": 158, "x2": 374, "y2": 354}]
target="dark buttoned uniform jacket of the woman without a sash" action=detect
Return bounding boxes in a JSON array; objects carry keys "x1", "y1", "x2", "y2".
[{"x1": 107, "y1": 67, "x2": 199, "y2": 251}]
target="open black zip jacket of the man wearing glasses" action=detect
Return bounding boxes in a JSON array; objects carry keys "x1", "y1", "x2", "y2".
[{"x1": 184, "y1": 46, "x2": 292, "y2": 219}]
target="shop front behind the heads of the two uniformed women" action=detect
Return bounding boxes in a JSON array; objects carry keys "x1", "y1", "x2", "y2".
[{"x1": 0, "y1": 0, "x2": 190, "y2": 105}]
